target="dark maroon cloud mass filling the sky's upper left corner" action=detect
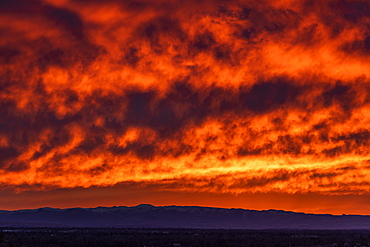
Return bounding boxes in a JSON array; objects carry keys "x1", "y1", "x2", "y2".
[{"x1": 0, "y1": 0, "x2": 105, "y2": 70}]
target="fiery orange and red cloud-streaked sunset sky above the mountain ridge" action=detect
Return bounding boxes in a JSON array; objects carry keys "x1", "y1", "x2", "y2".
[{"x1": 0, "y1": 0, "x2": 370, "y2": 214}]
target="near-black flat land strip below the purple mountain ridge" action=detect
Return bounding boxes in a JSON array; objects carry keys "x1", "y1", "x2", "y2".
[{"x1": 0, "y1": 228, "x2": 370, "y2": 247}]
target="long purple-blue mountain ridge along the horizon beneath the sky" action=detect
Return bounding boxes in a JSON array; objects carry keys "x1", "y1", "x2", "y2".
[{"x1": 0, "y1": 204, "x2": 370, "y2": 229}]
